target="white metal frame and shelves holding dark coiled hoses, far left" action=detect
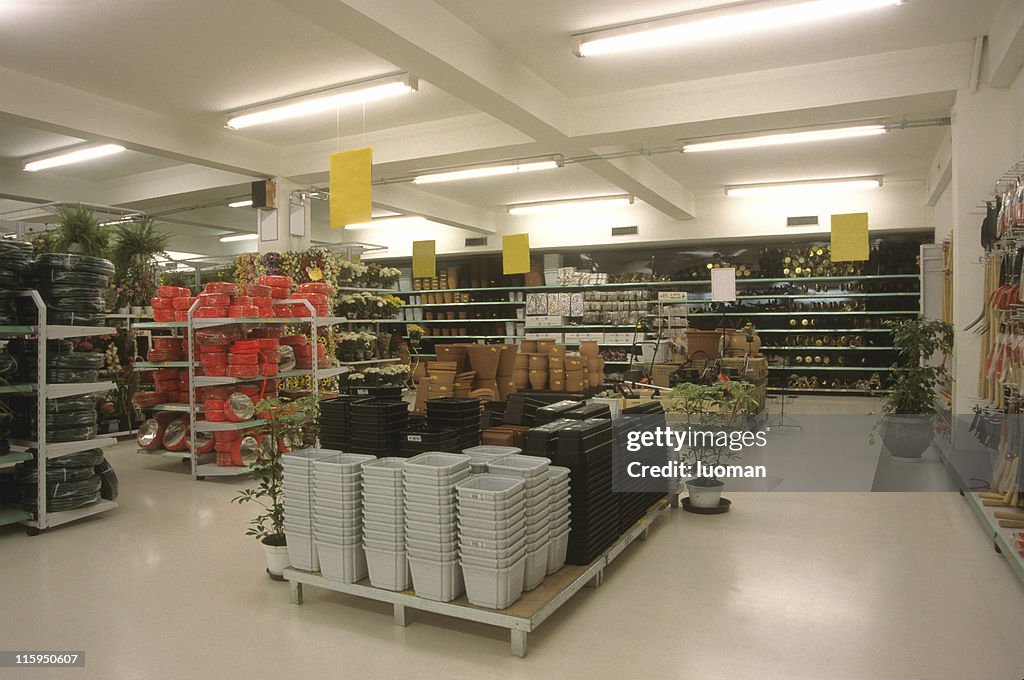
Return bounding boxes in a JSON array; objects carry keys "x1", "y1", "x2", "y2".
[{"x1": 11, "y1": 291, "x2": 118, "y2": 536}]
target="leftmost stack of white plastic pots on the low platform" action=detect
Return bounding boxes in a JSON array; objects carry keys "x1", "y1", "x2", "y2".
[{"x1": 281, "y1": 449, "x2": 338, "y2": 571}]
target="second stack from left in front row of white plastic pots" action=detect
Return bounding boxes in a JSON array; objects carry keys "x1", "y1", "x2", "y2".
[{"x1": 313, "y1": 454, "x2": 376, "y2": 583}]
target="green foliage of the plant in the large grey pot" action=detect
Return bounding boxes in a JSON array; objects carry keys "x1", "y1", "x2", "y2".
[{"x1": 882, "y1": 318, "x2": 953, "y2": 415}]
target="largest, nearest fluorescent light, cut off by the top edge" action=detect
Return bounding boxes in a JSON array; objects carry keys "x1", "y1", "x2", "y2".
[{"x1": 572, "y1": 0, "x2": 905, "y2": 56}]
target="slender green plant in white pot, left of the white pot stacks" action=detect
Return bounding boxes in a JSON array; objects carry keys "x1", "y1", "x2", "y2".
[{"x1": 231, "y1": 396, "x2": 319, "y2": 581}]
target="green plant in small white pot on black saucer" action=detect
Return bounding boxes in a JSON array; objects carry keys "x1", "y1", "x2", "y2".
[{"x1": 666, "y1": 380, "x2": 759, "y2": 509}]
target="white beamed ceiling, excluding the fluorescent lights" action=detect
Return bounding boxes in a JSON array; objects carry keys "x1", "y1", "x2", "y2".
[{"x1": 0, "y1": 0, "x2": 999, "y2": 252}]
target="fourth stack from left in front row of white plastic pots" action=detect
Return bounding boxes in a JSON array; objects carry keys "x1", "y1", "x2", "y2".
[{"x1": 406, "y1": 452, "x2": 469, "y2": 602}]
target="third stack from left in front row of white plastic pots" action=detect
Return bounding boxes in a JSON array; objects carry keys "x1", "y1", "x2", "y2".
[{"x1": 362, "y1": 458, "x2": 411, "y2": 591}]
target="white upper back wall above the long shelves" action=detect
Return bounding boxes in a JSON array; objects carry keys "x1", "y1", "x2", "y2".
[{"x1": 358, "y1": 182, "x2": 933, "y2": 258}]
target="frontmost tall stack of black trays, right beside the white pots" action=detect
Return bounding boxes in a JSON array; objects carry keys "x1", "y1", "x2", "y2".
[{"x1": 555, "y1": 418, "x2": 620, "y2": 564}]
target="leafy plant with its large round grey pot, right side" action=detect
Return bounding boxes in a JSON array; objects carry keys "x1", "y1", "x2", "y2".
[{"x1": 871, "y1": 318, "x2": 953, "y2": 459}]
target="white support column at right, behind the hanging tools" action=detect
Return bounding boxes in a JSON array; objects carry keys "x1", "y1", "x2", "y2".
[{"x1": 950, "y1": 87, "x2": 1018, "y2": 450}]
